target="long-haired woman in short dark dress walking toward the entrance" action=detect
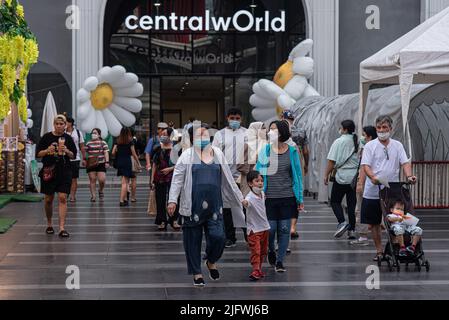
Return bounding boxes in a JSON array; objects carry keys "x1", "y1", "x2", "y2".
[{"x1": 112, "y1": 128, "x2": 140, "y2": 207}]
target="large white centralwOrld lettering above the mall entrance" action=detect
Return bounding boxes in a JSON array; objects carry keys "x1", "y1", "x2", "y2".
[{"x1": 125, "y1": 10, "x2": 285, "y2": 32}]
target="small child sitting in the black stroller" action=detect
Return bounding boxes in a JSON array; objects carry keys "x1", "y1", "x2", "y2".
[{"x1": 387, "y1": 200, "x2": 423, "y2": 257}]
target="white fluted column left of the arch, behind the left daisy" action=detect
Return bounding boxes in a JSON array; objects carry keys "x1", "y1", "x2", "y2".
[{"x1": 72, "y1": 0, "x2": 106, "y2": 118}]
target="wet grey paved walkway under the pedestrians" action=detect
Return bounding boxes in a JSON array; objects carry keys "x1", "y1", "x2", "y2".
[{"x1": 0, "y1": 180, "x2": 449, "y2": 299}]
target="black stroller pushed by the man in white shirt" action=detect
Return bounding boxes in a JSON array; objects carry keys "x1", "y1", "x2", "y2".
[{"x1": 377, "y1": 182, "x2": 430, "y2": 272}]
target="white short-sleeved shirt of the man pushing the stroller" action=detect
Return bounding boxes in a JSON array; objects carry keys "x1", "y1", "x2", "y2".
[{"x1": 361, "y1": 139, "x2": 410, "y2": 200}]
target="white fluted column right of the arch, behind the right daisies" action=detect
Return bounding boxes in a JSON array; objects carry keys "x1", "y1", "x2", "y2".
[{"x1": 305, "y1": 0, "x2": 339, "y2": 97}]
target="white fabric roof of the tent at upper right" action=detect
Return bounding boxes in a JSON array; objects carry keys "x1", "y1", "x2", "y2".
[{"x1": 360, "y1": 7, "x2": 449, "y2": 83}]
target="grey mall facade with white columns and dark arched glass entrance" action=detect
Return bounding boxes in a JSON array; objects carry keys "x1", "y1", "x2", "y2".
[{"x1": 21, "y1": 0, "x2": 449, "y2": 139}]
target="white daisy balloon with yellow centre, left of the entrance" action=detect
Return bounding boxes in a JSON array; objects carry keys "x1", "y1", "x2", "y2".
[{"x1": 77, "y1": 66, "x2": 143, "y2": 139}]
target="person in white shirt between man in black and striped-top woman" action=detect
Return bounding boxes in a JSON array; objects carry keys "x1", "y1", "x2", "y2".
[{"x1": 66, "y1": 117, "x2": 86, "y2": 202}]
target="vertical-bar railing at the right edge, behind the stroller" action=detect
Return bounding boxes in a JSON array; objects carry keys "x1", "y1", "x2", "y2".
[{"x1": 411, "y1": 161, "x2": 449, "y2": 209}]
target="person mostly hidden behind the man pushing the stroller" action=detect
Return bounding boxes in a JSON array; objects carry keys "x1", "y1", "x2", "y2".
[{"x1": 350, "y1": 126, "x2": 377, "y2": 246}]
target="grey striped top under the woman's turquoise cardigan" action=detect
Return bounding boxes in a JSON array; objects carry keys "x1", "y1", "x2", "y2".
[{"x1": 265, "y1": 150, "x2": 295, "y2": 199}]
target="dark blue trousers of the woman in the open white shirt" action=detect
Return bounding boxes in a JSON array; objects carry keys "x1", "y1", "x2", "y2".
[{"x1": 182, "y1": 214, "x2": 225, "y2": 275}]
